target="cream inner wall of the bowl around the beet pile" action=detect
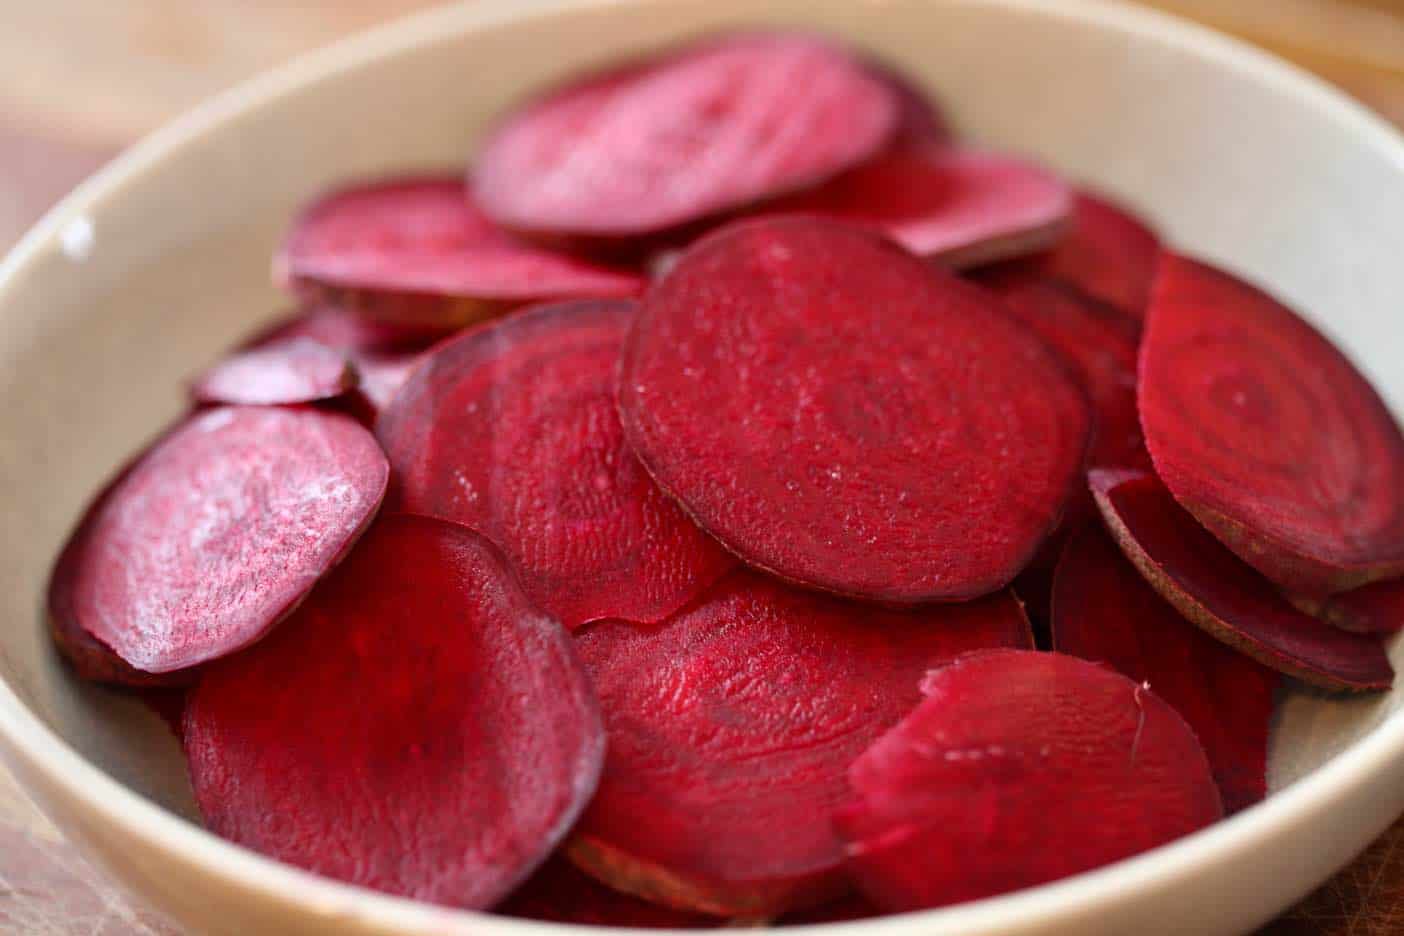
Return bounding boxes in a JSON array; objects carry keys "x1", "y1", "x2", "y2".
[{"x1": 0, "y1": 0, "x2": 1404, "y2": 914}]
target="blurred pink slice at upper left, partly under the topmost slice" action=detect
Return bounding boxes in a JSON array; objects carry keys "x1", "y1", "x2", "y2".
[{"x1": 275, "y1": 177, "x2": 642, "y2": 324}]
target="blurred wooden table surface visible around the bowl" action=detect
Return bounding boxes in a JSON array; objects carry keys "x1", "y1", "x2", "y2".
[{"x1": 0, "y1": 0, "x2": 1404, "y2": 936}]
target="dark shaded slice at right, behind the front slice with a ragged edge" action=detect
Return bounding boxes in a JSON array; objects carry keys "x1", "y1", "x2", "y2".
[{"x1": 1053, "y1": 526, "x2": 1280, "y2": 813}]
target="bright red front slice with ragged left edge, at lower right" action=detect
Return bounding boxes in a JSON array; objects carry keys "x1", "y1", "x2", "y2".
[{"x1": 835, "y1": 650, "x2": 1223, "y2": 911}]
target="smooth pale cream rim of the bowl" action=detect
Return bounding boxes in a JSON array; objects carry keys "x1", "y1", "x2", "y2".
[{"x1": 0, "y1": 0, "x2": 1404, "y2": 936}]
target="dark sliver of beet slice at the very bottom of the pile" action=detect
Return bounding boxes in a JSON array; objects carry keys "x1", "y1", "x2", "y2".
[{"x1": 496, "y1": 857, "x2": 726, "y2": 929}]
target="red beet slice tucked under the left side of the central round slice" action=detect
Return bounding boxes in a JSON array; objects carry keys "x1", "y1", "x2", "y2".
[{"x1": 376, "y1": 300, "x2": 734, "y2": 627}]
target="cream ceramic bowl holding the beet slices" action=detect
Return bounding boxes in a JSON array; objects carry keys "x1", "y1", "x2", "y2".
[{"x1": 0, "y1": 0, "x2": 1404, "y2": 936}]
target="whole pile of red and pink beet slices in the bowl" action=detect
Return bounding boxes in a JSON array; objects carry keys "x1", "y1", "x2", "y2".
[{"x1": 48, "y1": 32, "x2": 1404, "y2": 928}]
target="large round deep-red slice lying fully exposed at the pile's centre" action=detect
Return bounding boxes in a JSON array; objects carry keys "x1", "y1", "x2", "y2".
[{"x1": 619, "y1": 218, "x2": 1090, "y2": 603}]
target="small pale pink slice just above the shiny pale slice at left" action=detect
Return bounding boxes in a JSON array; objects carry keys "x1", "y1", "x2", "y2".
[{"x1": 191, "y1": 338, "x2": 357, "y2": 406}]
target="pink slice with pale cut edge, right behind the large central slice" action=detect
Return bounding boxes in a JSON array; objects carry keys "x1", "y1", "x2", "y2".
[{"x1": 767, "y1": 145, "x2": 1073, "y2": 268}]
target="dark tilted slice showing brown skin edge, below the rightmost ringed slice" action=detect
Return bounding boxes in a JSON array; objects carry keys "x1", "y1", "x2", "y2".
[{"x1": 1090, "y1": 470, "x2": 1394, "y2": 690}]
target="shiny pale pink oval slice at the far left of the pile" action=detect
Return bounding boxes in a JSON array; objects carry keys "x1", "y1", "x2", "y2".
[{"x1": 49, "y1": 407, "x2": 389, "y2": 674}]
